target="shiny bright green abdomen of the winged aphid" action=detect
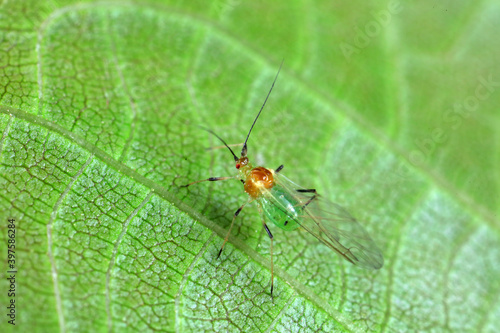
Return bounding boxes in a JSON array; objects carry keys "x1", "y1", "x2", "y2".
[{"x1": 261, "y1": 186, "x2": 301, "y2": 231}]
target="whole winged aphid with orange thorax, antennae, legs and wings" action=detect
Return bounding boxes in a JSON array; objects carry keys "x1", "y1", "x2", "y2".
[{"x1": 184, "y1": 61, "x2": 384, "y2": 295}]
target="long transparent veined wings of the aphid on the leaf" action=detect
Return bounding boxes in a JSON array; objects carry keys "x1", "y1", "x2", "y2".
[{"x1": 264, "y1": 174, "x2": 384, "y2": 269}]
